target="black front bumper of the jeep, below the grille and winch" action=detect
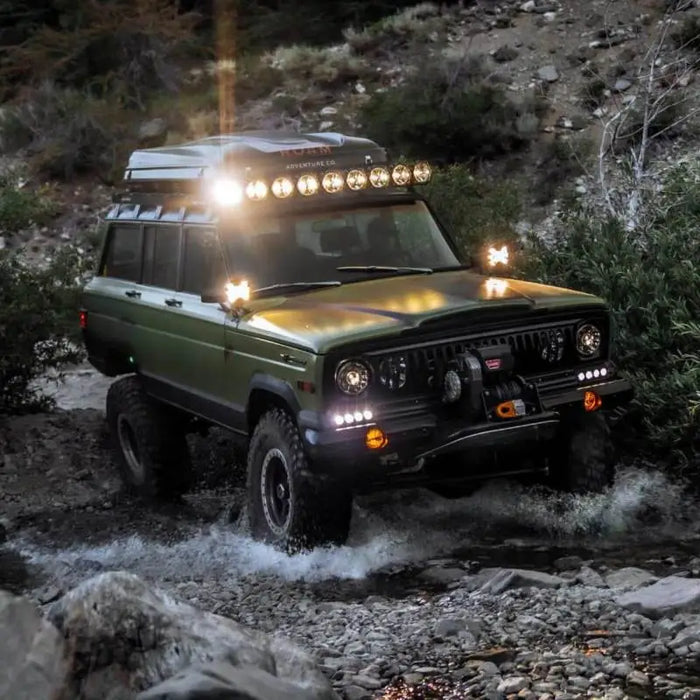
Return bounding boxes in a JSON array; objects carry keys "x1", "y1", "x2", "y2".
[{"x1": 299, "y1": 379, "x2": 633, "y2": 474}]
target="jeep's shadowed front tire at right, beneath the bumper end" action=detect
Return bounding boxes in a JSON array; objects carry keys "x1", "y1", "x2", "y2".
[{"x1": 549, "y1": 413, "x2": 615, "y2": 493}]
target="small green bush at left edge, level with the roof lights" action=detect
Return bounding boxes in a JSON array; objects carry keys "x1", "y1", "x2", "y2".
[{"x1": 0, "y1": 171, "x2": 58, "y2": 233}]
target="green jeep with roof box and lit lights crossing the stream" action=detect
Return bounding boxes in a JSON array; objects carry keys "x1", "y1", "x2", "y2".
[{"x1": 80, "y1": 132, "x2": 631, "y2": 549}]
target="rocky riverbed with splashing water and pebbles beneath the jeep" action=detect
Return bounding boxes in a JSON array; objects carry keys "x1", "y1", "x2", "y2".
[{"x1": 0, "y1": 370, "x2": 700, "y2": 700}]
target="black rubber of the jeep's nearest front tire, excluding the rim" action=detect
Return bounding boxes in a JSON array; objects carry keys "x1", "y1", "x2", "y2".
[{"x1": 247, "y1": 408, "x2": 352, "y2": 551}]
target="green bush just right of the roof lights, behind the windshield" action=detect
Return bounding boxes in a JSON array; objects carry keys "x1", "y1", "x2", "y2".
[{"x1": 421, "y1": 164, "x2": 522, "y2": 255}]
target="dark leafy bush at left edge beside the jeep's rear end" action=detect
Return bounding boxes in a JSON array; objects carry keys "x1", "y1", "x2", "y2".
[{"x1": 0, "y1": 247, "x2": 95, "y2": 415}]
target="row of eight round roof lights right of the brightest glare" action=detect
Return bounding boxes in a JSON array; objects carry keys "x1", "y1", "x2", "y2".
[{"x1": 238, "y1": 161, "x2": 432, "y2": 202}]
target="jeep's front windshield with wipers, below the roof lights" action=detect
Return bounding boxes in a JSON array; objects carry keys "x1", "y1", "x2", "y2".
[{"x1": 223, "y1": 201, "x2": 461, "y2": 293}]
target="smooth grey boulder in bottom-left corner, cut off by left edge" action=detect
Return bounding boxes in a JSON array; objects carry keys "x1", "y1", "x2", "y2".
[{"x1": 0, "y1": 591, "x2": 67, "y2": 700}]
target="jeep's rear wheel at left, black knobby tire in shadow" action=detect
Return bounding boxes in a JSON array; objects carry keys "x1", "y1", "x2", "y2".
[{"x1": 107, "y1": 375, "x2": 193, "y2": 500}]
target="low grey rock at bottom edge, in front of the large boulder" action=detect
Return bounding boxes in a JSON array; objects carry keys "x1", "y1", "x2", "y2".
[{"x1": 136, "y1": 661, "x2": 324, "y2": 700}]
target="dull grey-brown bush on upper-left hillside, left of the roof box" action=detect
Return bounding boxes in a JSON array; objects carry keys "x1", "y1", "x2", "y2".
[{"x1": 0, "y1": 83, "x2": 133, "y2": 181}]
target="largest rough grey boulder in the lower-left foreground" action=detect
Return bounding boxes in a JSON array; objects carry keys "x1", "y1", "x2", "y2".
[{"x1": 49, "y1": 572, "x2": 336, "y2": 700}]
